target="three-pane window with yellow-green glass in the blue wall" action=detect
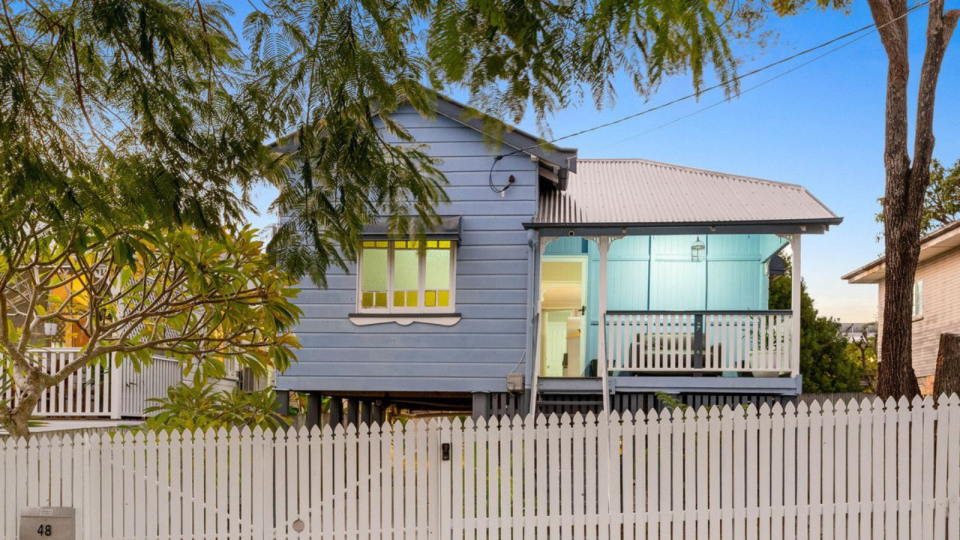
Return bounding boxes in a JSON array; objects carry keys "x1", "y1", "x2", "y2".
[{"x1": 357, "y1": 240, "x2": 456, "y2": 313}]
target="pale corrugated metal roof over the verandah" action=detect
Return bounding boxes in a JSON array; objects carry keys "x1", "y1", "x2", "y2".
[{"x1": 534, "y1": 159, "x2": 841, "y2": 226}]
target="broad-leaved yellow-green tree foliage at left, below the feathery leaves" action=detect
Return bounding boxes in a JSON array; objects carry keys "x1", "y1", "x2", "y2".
[{"x1": 0, "y1": 217, "x2": 302, "y2": 408}]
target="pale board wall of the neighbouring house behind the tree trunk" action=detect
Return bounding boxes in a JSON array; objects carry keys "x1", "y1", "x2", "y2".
[{"x1": 877, "y1": 249, "x2": 960, "y2": 377}]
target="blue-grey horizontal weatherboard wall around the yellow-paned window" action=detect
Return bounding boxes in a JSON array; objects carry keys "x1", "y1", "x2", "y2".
[{"x1": 277, "y1": 107, "x2": 538, "y2": 392}]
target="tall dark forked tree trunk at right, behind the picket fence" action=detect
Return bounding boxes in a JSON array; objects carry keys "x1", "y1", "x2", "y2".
[{"x1": 869, "y1": 0, "x2": 960, "y2": 399}]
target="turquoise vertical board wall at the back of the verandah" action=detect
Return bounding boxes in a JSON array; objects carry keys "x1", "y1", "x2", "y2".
[{"x1": 544, "y1": 234, "x2": 786, "y2": 374}]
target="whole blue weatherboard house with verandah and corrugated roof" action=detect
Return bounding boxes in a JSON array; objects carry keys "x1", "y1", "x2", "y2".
[{"x1": 277, "y1": 98, "x2": 841, "y2": 419}]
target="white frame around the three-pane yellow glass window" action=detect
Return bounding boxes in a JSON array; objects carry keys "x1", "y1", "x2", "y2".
[{"x1": 356, "y1": 238, "x2": 459, "y2": 316}]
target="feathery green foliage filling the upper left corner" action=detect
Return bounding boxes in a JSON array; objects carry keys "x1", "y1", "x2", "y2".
[{"x1": 0, "y1": 0, "x2": 269, "y2": 248}]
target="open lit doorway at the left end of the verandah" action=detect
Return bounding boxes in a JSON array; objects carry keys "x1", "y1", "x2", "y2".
[{"x1": 540, "y1": 256, "x2": 587, "y2": 377}]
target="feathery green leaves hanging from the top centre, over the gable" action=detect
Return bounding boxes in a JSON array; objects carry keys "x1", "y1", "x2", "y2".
[{"x1": 244, "y1": 0, "x2": 752, "y2": 285}]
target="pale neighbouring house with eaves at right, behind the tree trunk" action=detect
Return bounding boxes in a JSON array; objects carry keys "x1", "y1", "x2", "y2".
[{"x1": 843, "y1": 221, "x2": 960, "y2": 394}]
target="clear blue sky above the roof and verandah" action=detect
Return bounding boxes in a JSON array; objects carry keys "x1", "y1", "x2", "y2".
[{"x1": 235, "y1": 0, "x2": 960, "y2": 322}]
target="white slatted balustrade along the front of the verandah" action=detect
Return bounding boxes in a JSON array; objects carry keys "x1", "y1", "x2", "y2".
[{"x1": 605, "y1": 311, "x2": 799, "y2": 375}]
